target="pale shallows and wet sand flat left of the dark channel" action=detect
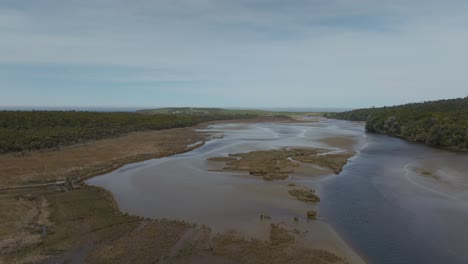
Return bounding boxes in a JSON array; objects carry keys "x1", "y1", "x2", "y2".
[{"x1": 87, "y1": 119, "x2": 363, "y2": 263}]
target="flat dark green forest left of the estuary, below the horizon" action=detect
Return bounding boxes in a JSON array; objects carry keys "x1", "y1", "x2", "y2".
[{"x1": 0, "y1": 111, "x2": 253, "y2": 153}]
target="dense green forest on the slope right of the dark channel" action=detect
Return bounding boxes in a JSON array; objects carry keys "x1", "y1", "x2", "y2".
[{"x1": 326, "y1": 97, "x2": 468, "y2": 150}]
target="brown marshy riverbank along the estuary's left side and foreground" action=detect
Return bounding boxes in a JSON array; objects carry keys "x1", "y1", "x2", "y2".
[{"x1": 0, "y1": 119, "x2": 364, "y2": 263}]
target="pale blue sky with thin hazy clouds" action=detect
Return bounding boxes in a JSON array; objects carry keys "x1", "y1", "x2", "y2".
[{"x1": 0, "y1": 0, "x2": 468, "y2": 108}]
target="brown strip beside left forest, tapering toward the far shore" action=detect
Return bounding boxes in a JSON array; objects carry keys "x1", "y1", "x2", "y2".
[{"x1": 0, "y1": 116, "x2": 295, "y2": 187}]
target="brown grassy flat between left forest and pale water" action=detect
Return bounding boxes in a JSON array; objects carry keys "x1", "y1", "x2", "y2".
[{"x1": 0, "y1": 116, "x2": 292, "y2": 187}]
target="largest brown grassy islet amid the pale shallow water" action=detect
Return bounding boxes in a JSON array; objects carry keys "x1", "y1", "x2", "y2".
[{"x1": 208, "y1": 148, "x2": 355, "y2": 180}]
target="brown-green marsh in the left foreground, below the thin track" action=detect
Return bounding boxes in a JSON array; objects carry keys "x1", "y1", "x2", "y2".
[{"x1": 0, "y1": 187, "x2": 354, "y2": 263}]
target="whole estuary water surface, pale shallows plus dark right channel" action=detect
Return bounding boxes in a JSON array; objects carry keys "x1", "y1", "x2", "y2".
[{"x1": 87, "y1": 119, "x2": 468, "y2": 263}]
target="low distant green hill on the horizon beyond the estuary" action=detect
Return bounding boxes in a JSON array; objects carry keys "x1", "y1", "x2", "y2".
[{"x1": 137, "y1": 107, "x2": 271, "y2": 115}]
